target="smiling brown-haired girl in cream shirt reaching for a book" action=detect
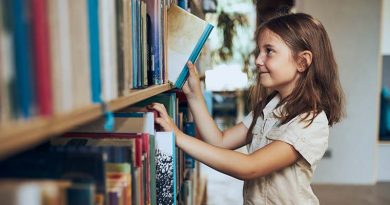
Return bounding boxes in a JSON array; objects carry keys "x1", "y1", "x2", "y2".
[{"x1": 150, "y1": 14, "x2": 344, "y2": 205}]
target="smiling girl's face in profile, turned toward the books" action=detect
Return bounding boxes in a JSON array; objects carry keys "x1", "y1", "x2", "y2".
[{"x1": 255, "y1": 29, "x2": 299, "y2": 98}]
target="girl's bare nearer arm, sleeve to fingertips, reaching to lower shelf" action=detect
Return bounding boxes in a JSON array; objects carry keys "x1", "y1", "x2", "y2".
[{"x1": 150, "y1": 104, "x2": 300, "y2": 180}]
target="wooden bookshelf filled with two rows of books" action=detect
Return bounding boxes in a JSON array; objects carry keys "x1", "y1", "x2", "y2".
[{"x1": 0, "y1": 0, "x2": 206, "y2": 205}]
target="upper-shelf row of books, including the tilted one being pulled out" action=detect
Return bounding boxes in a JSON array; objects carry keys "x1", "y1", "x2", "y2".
[{"x1": 0, "y1": 0, "x2": 212, "y2": 123}]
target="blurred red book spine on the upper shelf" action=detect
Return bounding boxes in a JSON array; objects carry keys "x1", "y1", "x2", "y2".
[{"x1": 31, "y1": 0, "x2": 53, "y2": 116}]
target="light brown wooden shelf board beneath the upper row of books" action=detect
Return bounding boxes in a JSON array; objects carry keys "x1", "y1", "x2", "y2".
[{"x1": 0, "y1": 84, "x2": 172, "y2": 159}]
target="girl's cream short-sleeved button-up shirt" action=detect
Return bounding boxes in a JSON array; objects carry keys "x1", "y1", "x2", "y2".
[{"x1": 243, "y1": 95, "x2": 329, "y2": 205}]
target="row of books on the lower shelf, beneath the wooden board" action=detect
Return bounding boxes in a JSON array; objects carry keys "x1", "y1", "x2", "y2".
[{"x1": 0, "y1": 92, "x2": 201, "y2": 205}]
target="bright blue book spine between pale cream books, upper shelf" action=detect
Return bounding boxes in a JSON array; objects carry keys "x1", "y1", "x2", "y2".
[{"x1": 88, "y1": 0, "x2": 102, "y2": 103}]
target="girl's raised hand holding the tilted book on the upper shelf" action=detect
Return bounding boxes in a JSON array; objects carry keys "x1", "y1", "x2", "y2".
[{"x1": 183, "y1": 61, "x2": 202, "y2": 99}]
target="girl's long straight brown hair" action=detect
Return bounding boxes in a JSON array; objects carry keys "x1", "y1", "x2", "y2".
[{"x1": 247, "y1": 13, "x2": 344, "y2": 143}]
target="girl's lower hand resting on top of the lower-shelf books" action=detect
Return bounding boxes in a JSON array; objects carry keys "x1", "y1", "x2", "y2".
[{"x1": 147, "y1": 103, "x2": 181, "y2": 136}]
